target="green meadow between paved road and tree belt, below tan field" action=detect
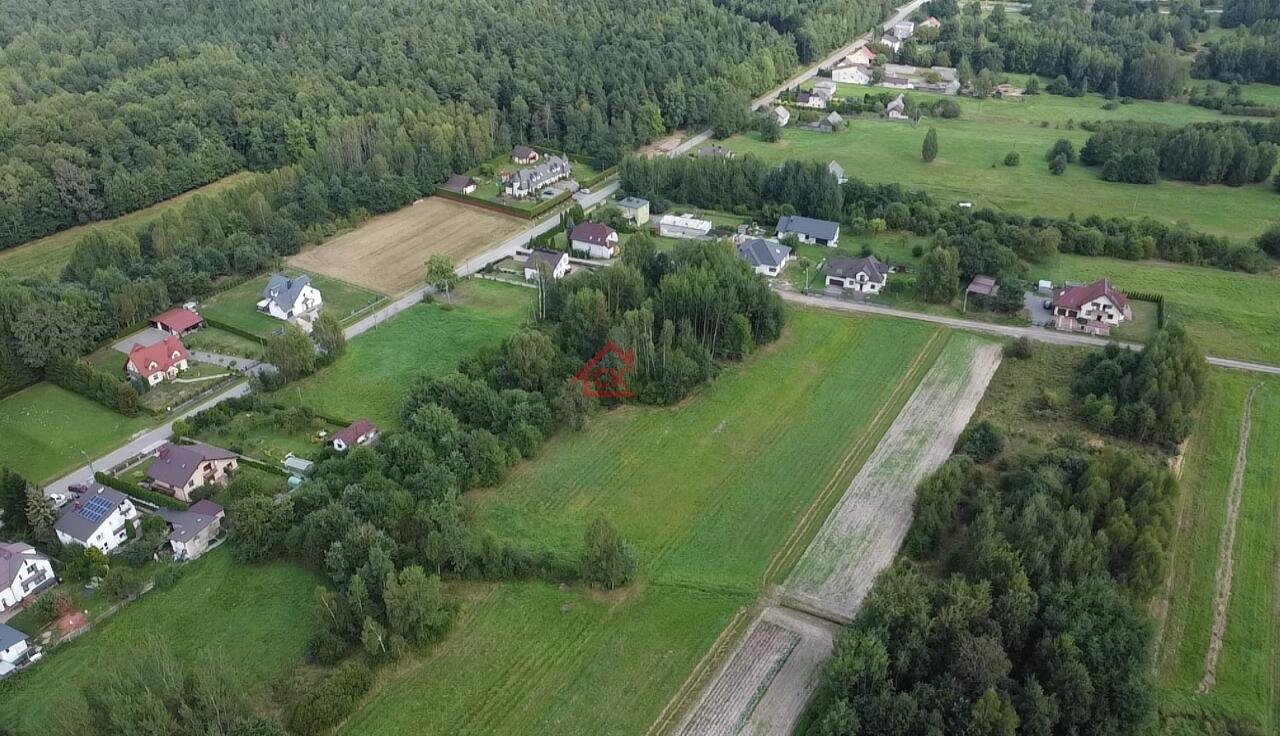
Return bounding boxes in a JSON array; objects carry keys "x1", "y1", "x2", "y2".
[{"x1": 276, "y1": 279, "x2": 534, "y2": 426}]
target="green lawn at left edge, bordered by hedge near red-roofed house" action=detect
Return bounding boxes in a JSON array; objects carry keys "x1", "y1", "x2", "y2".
[{"x1": 0, "y1": 383, "x2": 148, "y2": 483}]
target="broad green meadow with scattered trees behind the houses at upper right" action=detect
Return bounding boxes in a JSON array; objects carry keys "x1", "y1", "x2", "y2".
[{"x1": 724, "y1": 84, "x2": 1280, "y2": 238}]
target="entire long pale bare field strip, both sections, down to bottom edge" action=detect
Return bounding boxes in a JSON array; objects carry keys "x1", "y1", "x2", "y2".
[{"x1": 658, "y1": 334, "x2": 1000, "y2": 736}]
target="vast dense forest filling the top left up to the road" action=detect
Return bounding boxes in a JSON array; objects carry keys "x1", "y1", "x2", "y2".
[{"x1": 0, "y1": 0, "x2": 888, "y2": 247}]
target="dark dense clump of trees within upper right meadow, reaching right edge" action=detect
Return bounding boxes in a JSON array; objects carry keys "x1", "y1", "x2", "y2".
[{"x1": 1080, "y1": 120, "x2": 1280, "y2": 187}]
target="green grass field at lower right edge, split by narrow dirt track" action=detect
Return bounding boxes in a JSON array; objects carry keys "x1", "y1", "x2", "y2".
[{"x1": 1156, "y1": 371, "x2": 1280, "y2": 733}]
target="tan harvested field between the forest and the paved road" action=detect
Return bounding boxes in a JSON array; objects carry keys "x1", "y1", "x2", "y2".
[{"x1": 288, "y1": 197, "x2": 527, "y2": 296}]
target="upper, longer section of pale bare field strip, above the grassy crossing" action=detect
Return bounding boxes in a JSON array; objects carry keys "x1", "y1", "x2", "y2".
[{"x1": 785, "y1": 334, "x2": 1000, "y2": 622}]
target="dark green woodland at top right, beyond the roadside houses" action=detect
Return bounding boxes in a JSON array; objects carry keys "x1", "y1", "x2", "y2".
[{"x1": 931, "y1": 0, "x2": 1208, "y2": 100}]
